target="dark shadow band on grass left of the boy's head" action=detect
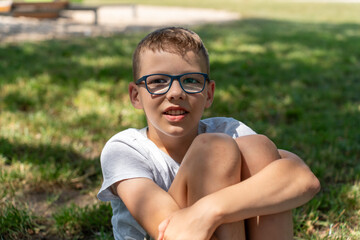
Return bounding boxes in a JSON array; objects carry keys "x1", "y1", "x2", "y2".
[{"x1": 0, "y1": 36, "x2": 136, "y2": 89}]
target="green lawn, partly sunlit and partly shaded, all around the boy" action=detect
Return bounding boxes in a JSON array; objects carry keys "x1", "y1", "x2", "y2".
[{"x1": 0, "y1": 0, "x2": 360, "y2": 239}]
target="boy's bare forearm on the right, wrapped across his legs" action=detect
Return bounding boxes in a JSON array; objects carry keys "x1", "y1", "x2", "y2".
[{"x1": 199, "y1": 155, "x2": 320, "y2": 225}]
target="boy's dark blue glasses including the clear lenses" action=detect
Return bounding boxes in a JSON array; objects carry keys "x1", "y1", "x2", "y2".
[{"x1": 135, "y1": 72, "x2": 210, "y2": 95}]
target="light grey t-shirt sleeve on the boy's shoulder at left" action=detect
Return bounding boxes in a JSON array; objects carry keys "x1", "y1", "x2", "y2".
[{"x1": 98, "y1": 140, "x2": 153, "y2": 201}]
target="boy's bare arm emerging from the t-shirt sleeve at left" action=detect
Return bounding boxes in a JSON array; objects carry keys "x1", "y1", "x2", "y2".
[{"x1": 112, "y1": 178, "x2": 179, "y2": 238}]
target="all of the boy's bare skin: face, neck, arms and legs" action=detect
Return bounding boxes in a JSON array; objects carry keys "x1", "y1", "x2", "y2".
[{"x1": 112, "y1": 50, "x2": 319, "y2": 240}]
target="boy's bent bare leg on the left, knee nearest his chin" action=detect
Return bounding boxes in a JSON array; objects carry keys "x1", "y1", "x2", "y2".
[{"x1": 169, "y1": 134, "x2": 245, "y2": 240}]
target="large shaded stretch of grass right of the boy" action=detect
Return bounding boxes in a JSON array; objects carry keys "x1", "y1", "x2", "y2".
[{"x1": 198, "y1": 19, "x2": 360, "y2": 182}]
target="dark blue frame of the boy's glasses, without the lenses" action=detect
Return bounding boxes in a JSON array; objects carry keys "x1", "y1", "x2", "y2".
[{"x1": 135, "y1": 72, "x2": 210, "y2": 95}]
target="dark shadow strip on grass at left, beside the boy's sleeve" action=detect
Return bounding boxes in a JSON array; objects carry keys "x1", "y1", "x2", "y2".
[{"x1": 0, "y1": 137, "x2": 101, "y2": 188}]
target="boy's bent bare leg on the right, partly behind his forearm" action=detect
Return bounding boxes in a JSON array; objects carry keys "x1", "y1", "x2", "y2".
[{"x1": 236, "y1": 135, "x2": 293, "y2": 240}]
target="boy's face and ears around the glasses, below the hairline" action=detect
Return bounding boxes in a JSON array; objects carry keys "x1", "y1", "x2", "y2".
[{"x1": 129, "y1": 50, "x2": 215, "y2": 140}]
